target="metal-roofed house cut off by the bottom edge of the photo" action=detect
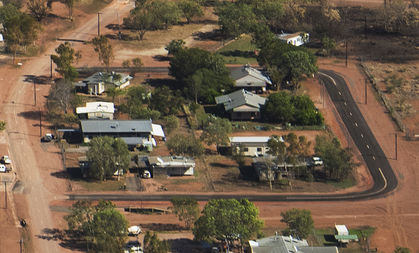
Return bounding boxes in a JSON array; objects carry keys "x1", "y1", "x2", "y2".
[{"x1": 249, "y1": 235, "x2": 339, "y2": 253}]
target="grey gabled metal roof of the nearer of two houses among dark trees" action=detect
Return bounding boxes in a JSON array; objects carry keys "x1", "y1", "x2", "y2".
[{"x1": 215, "y1": 89, "x2": 266, "y2": 111}]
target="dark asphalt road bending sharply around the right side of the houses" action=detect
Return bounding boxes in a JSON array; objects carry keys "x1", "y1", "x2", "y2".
[{"x1": 69, "y1": 70, "x2": 397, "y2": 201}]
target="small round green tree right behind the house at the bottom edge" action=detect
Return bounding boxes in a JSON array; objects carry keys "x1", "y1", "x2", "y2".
[{"x1": 281, "y1": 208, "x2": 314, "y2": 238}]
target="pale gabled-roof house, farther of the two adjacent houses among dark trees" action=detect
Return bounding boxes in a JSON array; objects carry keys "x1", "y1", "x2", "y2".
[{"x1": 230, "y1": 65, "x2": 272, "y2": 92}]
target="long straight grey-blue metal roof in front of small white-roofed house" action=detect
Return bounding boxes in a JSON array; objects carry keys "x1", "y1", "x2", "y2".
[{"x1": 80, "y1": 120, "x2": 153, "y2": 133}]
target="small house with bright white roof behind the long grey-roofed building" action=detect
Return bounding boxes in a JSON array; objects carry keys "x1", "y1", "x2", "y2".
[{"x1": 76, "y1": 102, "x2": 115, "y2": 120}]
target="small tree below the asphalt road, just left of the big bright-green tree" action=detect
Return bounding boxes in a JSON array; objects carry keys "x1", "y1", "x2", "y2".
[{"x1": 170, "y1": 197, "x2": 199, "y2": 229}]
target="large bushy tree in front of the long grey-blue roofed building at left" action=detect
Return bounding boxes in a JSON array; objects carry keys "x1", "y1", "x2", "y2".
[{"x1": 87, "y1": 136, "x2": 130, "y2": 180}]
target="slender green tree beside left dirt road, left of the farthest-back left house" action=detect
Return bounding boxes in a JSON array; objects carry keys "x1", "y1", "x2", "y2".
[{"x1": 51, "y1": 42, "x2": 81, "y2": 81}]
